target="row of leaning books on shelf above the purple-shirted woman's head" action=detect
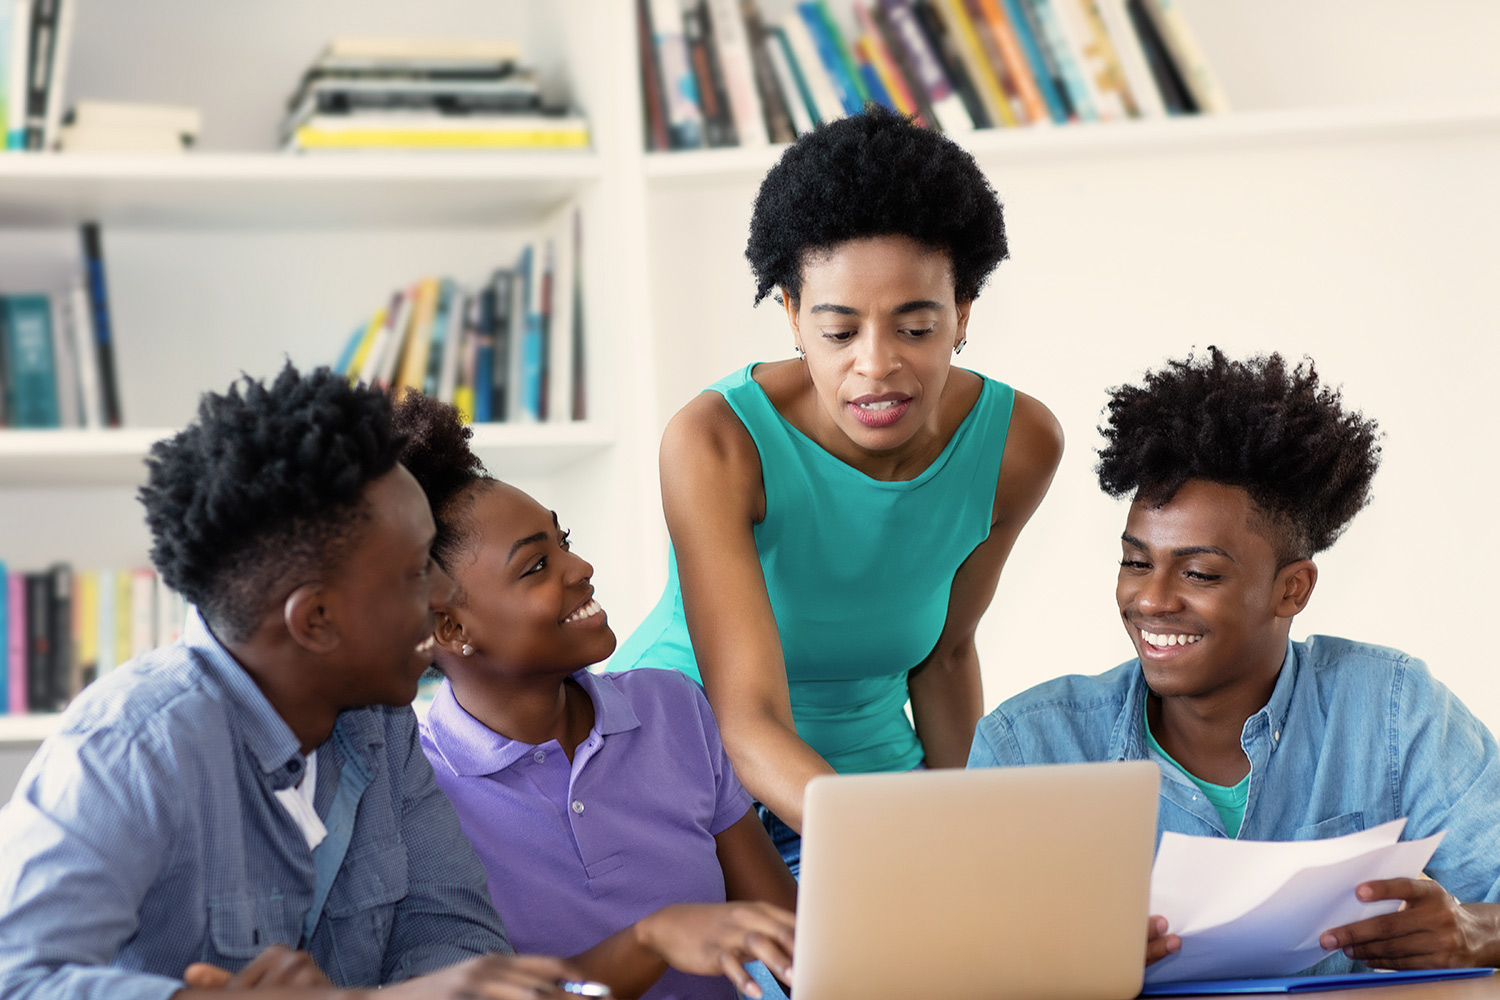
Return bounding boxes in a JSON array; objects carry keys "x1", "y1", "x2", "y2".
[{"x1": 335, "y1": 211, "x2": 588, "y2": 423}]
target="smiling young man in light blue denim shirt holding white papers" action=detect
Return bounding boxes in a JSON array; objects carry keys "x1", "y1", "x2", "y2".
[{"x1": 969, "y1": 348, "x2": 1500, "y2": 972}]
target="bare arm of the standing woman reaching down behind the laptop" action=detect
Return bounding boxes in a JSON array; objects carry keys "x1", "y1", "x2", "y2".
[{"x1": 662, "y1": 393, "x2": 834, "y2": 832}]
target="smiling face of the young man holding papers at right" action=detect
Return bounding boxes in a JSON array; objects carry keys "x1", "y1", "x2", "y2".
[{"x1": 1115, "y1": 480, "x2": 1317, "y2": 712}]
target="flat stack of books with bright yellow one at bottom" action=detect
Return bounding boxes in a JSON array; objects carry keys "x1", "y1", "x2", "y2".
[{"x1": 281, "y1": 37, "x2": 588, "y2": 151}]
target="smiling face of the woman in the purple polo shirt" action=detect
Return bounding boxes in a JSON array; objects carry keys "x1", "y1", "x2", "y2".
[{"x1": 447, "y1": 483, "x2": 615, "y2": 676}]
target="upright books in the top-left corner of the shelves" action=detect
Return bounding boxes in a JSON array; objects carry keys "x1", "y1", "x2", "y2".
[{"x1": 0, "y1": 0, "x2": 78, "y2": 151}]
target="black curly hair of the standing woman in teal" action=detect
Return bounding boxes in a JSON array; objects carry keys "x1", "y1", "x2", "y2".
[{"x1": 746, "y1": 105, "x2": 1010, "y2": 303}]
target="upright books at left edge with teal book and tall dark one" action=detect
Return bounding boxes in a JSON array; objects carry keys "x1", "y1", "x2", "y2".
[{"x1": 0, "y1": 222, "x2": 120, "y2": 429}]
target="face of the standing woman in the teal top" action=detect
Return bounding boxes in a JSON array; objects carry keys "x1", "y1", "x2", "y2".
[{"x1": 786, "y1": 235, "x2": 972, "y2": 464}]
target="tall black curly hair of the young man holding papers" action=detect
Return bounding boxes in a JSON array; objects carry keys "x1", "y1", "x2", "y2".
[{"x1": 1095, "y1": 346, "x2": 1380, "y2": 565}]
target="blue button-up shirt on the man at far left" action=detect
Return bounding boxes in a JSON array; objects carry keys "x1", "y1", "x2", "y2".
[{"x1": 0, "y1": 615, "x2": 509, "y2": 1000}]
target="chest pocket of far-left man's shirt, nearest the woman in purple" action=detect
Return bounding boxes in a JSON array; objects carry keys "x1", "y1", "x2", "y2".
[{"x1": 312, "y1": 840, "x2": 408, "y2": 985}]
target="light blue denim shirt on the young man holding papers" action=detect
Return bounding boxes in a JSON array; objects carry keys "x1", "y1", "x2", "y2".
[{"x1": 969, "y1": 636, "x2": 1500, "y2": 973}]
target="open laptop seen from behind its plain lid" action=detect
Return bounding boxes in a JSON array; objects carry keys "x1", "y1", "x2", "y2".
[{"x1": 794, "y1": 762, "x2": 1161, "y2": 1000}]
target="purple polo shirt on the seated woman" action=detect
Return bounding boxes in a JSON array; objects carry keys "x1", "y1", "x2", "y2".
[{"x1": 422, "y1": 669, "x2": 750, "y2": 1000}]
